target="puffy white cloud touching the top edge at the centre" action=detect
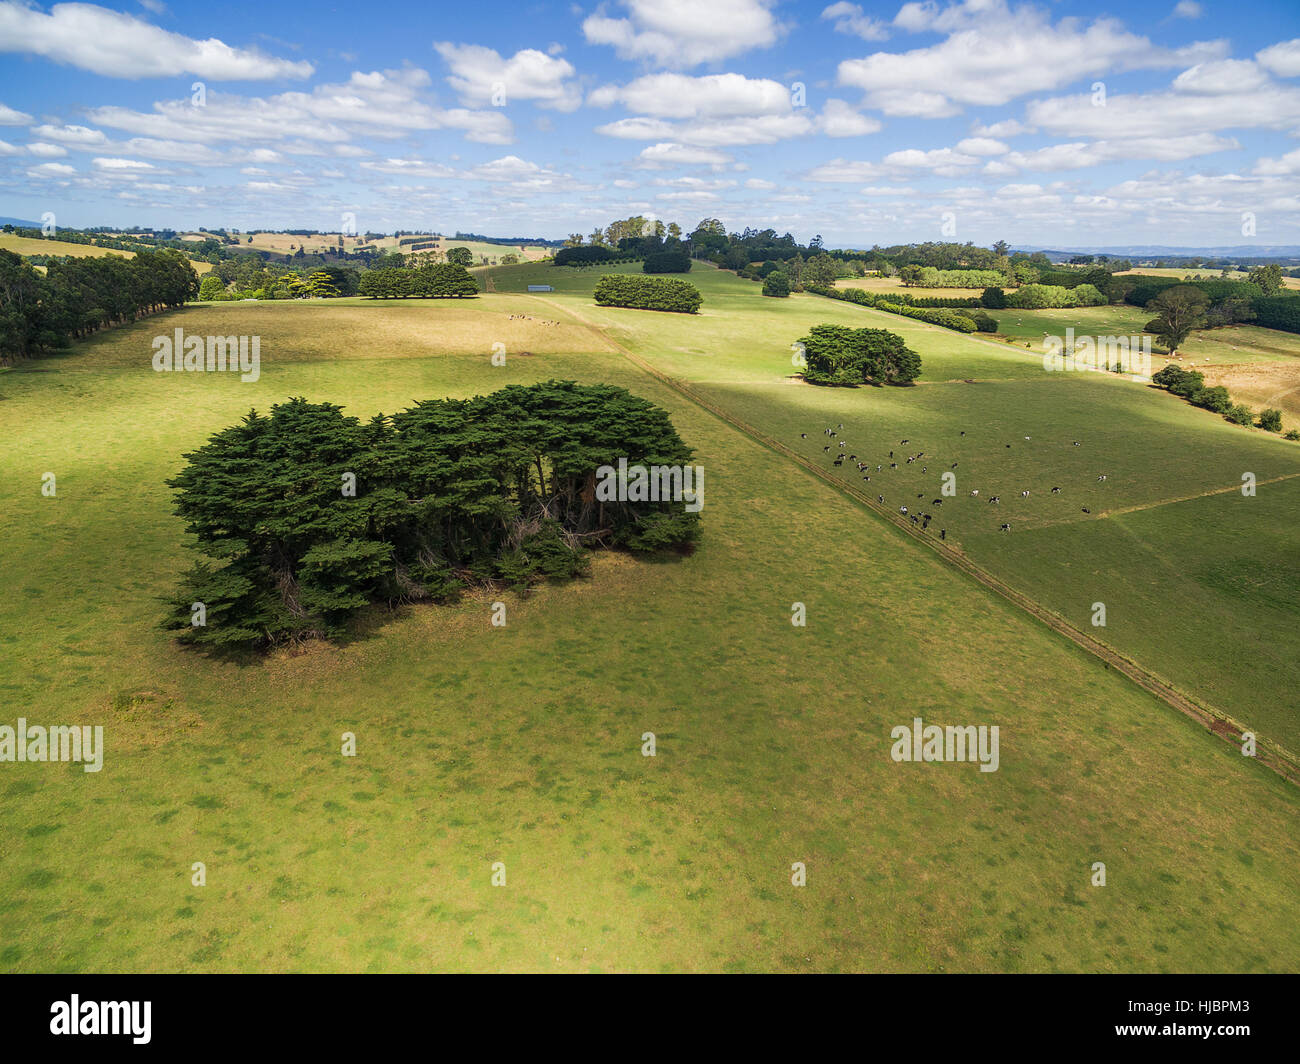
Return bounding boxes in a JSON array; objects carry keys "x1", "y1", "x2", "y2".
[{"x1": 582, "y1": 0, "x2": 783, "y2": 68}]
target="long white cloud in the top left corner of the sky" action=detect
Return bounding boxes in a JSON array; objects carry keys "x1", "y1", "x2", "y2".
[{"x1": 0, "y1": 0, "x2": 315, "y2": 81}]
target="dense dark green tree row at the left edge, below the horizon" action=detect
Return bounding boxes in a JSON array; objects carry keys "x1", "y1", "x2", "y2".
[{"x1": 0, "y1": 250, "x2": 199, "y2": 360}]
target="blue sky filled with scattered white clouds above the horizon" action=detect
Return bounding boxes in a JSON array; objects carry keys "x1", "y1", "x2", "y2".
[{"x1": 0, "y1": 0, "x2": 1300, "y2": 247}]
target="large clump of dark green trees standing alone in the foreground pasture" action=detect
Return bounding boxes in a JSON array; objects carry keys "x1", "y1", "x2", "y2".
[{"x1": 164, "y1": 381, "x2": 699, "y2": 646}]
